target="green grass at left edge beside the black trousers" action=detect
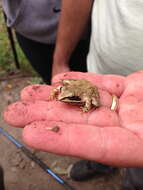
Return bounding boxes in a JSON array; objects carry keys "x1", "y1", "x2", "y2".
[{"x1": 0, "y1": 9, "x2": 36, "y2": 75}]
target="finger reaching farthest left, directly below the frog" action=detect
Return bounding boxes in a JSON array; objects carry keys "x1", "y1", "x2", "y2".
[{"x1": 4, "y1": 101, "x2": 119, "y2": 127}]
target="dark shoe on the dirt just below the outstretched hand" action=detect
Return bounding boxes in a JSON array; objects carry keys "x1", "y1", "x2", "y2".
[{"x1": 69, "y1": 160, "x2": 115, "y2": 181}]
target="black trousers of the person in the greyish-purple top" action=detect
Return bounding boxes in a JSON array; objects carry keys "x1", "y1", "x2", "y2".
[{"x1": 16, "y1": 33, "x2": 89, "y2": 84}]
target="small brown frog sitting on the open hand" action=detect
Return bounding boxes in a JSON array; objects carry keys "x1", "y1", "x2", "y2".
[{"x1": 51, "y1": 79, "x2": 100, "y2": 112}]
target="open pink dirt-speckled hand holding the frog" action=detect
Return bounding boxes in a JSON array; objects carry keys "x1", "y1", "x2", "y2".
[{"x1": 4, "y1": 72, "x2": 143, "y2": 167}]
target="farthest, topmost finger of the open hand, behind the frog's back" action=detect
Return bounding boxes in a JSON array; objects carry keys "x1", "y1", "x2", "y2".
[{"x1": 52, "y1": 72, "x2": 125, "y2": 96}]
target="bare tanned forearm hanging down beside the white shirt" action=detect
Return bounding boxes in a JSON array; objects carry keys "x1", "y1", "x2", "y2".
[{"x1": 54, "y1": 0, "x2": 93, "y2": 63}]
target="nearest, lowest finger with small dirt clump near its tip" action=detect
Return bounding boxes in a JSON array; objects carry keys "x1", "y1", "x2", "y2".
[{"x1": 23, "y1": 121, "x2": 143, "y2": 167}]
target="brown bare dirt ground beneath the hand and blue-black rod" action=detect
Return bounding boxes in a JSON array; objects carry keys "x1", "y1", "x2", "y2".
[{"x1": 0, "y1": 78, "x2": 123, "y2": 190}]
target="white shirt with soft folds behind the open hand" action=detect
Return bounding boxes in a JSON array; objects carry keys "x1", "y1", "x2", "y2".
[{"x1": 87, "y1": 0, "x2": 143, "y2": 75}]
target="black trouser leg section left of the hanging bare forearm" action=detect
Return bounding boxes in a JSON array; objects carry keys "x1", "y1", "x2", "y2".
[{"x1": 16, "y1": 33, "x2": 54, "y2": 84}]
